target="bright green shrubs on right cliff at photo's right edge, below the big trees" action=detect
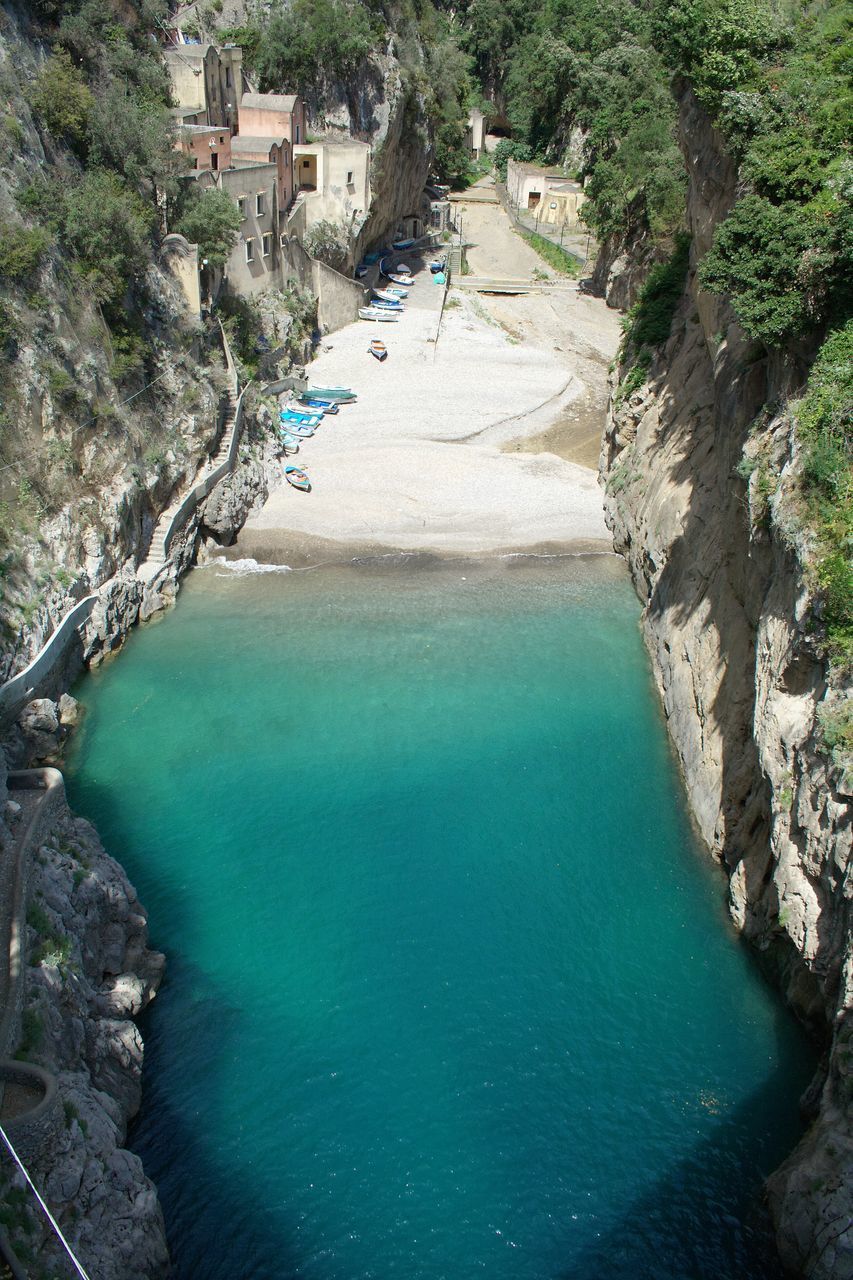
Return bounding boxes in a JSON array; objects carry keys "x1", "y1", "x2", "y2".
[{"x1": 795, "y1": 320, "x2": 853, "y2": 671}]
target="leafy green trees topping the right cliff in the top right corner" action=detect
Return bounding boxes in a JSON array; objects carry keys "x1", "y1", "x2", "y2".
[{"x1": 660, "y1": 0, "x2": 853, "y2": 347}]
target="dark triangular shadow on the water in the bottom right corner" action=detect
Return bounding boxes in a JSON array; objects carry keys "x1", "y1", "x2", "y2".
[{"x1": 553, "y1": 1007, "x2": 798, "y2": 1280}]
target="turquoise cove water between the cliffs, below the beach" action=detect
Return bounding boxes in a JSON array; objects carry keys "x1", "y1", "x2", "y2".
[{"x1": 69, "y1": 559, "x2": 813, "y2": 1280}]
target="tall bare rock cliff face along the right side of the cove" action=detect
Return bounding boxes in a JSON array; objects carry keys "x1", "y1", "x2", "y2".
[{"x1": 601, "y1": 92, "x2": 853, "y2": 1280}]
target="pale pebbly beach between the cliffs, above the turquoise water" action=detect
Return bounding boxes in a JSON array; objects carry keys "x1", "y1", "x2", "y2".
[{"x1": 231, "y1": 195, "x2": 617, "y2": 562}]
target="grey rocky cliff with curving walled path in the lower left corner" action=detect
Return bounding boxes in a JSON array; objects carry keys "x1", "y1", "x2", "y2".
[{"x1": 0, "y1": 754, "x2": 168, "y2": 1280}]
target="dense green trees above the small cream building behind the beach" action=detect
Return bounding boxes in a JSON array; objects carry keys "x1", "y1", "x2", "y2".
[{"x1": 461, "y1": 0, "x2": 685, "y2": 241}]
